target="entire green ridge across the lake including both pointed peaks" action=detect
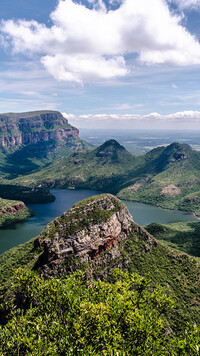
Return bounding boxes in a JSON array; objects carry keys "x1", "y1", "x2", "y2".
[{"x1": 15, "y1": 140, "x2": 200, "y2": 215}]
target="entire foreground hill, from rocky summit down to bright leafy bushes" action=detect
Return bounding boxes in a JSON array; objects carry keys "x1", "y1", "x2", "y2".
[{"x1": 0, "y1": 194, "x2": 200, "y2": 356}]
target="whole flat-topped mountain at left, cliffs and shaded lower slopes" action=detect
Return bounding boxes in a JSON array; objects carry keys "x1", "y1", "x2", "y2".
[{"x1": 0, "y1": 111, "x2": 90, "y2": 178}]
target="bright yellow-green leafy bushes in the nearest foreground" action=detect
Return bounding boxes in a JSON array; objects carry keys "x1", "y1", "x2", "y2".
[{"x1": 0, "y1": 269, "x2": 177, "y2": 355}]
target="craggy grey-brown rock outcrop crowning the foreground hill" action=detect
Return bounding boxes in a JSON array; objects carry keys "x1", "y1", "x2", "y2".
[{"x1": 34, "y1": 194, "x2": 155, "y2": 274}]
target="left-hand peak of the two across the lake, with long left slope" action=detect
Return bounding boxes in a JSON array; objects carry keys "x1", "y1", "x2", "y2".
[{"x1": 16, "y1": 140, "x2": 136, "y2": 193}]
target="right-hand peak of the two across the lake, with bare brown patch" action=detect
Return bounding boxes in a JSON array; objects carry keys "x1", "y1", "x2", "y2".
[{"x1": 119, "y1": 143, "x2": 200, "y2": 215}]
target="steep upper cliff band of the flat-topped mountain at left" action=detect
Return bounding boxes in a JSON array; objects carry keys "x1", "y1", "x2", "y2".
[{"x1": 0, "y1": 111, "x2": 79, "y2": 147}]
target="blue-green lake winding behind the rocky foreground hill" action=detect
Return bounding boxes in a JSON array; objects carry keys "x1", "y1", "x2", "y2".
[{"x1": 0, "y1": 189, "x2": 197, "y2": 254}]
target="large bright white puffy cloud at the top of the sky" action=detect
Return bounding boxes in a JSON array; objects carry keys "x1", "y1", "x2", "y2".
[{"x1": 1, "y1": 0, "x2": 200, "y2": 83}]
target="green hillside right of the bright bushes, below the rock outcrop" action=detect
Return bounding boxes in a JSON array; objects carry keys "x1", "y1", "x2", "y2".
[{"x1": 115, "y1": 229, "x2": 200, "y2": 331}]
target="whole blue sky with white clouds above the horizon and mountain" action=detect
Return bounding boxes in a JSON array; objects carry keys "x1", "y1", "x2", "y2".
[{"x1": 0, "y1": 0, "x2": 200, "y2": 130}]
